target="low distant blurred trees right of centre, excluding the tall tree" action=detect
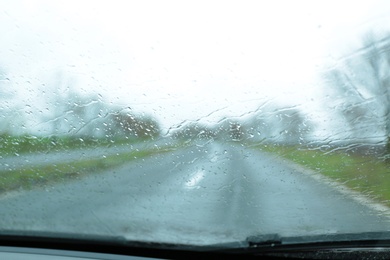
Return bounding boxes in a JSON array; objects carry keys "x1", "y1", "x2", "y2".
[{"x1": 172, "y1": 106, "x2": 313, "y2": 145}]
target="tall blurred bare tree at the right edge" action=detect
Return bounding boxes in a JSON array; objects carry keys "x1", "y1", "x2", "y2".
[{"x1": 325, "y1": 33, "x2": 390, "y2": 162}]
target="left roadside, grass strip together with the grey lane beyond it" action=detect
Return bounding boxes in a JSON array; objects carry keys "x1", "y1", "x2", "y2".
[{"x1": 0, "y1": 139, "x2": 185, "y2": 196}]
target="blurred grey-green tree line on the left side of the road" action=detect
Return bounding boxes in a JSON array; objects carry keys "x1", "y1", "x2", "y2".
[{"x1": 0, "y1": 70, "x2": 160, "y2": 140}]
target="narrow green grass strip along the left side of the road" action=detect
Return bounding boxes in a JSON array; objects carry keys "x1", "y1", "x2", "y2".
[{"x1": 0, "y1": 148, "x2": 171, "y2": 193}]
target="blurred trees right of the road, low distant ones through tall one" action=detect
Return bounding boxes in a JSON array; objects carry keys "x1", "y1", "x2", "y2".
[{"x1": 173, "y1": 29, "x2": 390, "y2": 159}]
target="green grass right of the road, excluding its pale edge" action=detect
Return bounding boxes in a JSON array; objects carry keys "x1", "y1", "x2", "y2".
[{"x1": 257, "y1": 145, "x2": 390, "y2": 206}]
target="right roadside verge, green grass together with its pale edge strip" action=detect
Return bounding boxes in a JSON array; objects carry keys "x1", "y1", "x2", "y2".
[{"x1": 249, "y1": 145, "x2": 390, "y2": 218}]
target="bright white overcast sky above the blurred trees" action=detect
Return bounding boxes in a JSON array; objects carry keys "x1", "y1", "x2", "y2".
[{"x1": 0, "y1": 0, "x2": 390, "y2": 132}]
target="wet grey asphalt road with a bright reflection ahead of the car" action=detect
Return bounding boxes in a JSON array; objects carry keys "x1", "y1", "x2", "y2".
[{"x1": 0, "y1": 143, "x2": 390, "y2": 244}]
